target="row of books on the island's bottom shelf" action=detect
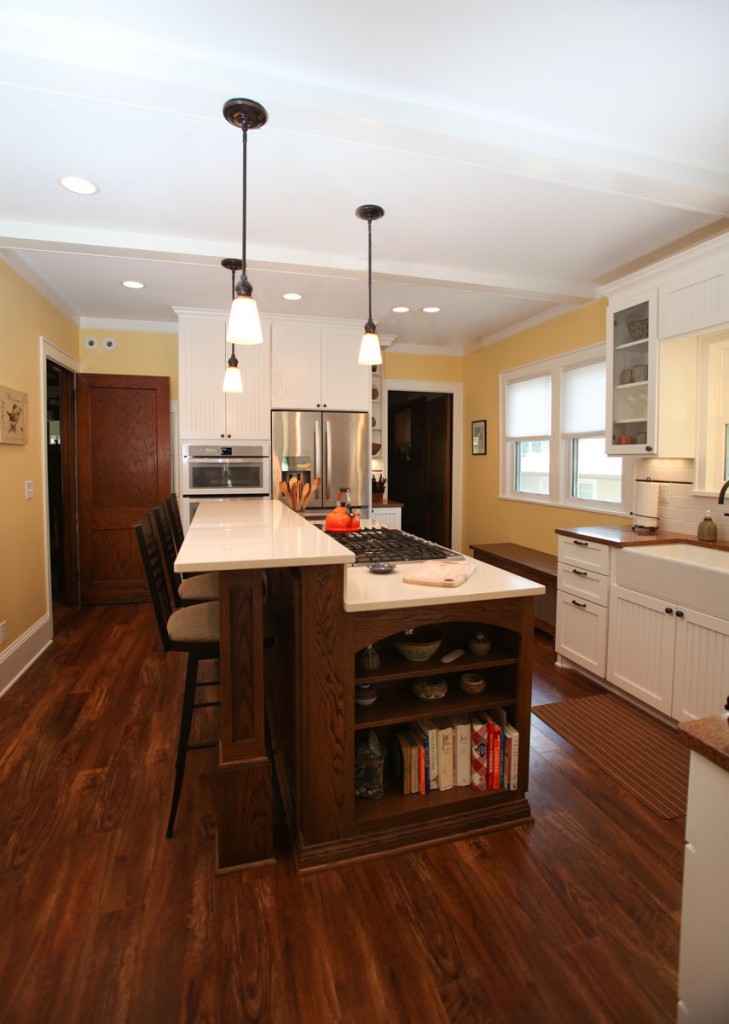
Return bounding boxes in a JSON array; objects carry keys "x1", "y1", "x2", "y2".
[{"x1": 390, "y1": 708, "x2": 519, "y2": 795}]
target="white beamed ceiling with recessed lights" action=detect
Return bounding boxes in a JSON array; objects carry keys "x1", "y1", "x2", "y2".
[{"x1": 0, "y1": 0, "x2": 729, "y2": 353}]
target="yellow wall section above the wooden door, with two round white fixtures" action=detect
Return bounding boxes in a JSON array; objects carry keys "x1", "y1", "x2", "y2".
[{"x1": 79, "y1": 328, "x2": 178, "y2": 401}]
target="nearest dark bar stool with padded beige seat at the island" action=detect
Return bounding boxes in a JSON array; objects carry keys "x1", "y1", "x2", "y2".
[{"x1": 134, "y1": 512, "x2": 220, "y2": 839}]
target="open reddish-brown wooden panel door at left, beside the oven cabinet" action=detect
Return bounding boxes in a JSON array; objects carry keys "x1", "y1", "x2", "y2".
[{"x1": 77, "y1": 374, "x2": 171, "y2": 604}]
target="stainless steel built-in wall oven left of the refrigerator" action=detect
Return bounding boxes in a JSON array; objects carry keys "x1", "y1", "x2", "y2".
[{"x1": 180, "y1": 440, "x2": 271, "y2": 529}]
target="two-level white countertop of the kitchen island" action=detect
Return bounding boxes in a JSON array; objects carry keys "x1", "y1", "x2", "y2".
[{"x1": 175, "y1": 498, "x2": 545, "y2": 611}]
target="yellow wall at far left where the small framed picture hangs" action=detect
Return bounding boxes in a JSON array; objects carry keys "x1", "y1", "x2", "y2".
[{"x1": 0, "y1": 260, "x2": 78, "y2": 653}]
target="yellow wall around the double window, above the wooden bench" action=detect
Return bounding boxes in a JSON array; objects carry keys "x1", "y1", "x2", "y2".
[{"x1": 463, "y1": 300, "x2": 626, "y2": 554}]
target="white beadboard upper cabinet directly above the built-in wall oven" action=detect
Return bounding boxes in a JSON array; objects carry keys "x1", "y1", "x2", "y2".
[{"x1": 178, "y1": 311, "x2": 270, "y2": 440}]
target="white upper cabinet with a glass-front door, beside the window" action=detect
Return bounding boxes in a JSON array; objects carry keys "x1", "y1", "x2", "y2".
[{"x1": 606, "y1": 292, "x2": 657, "y2": 455}]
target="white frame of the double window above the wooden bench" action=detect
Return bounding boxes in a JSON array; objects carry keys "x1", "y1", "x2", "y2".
[{"x1": 500, "y1": 344, "x2": 634, "y2": 516}]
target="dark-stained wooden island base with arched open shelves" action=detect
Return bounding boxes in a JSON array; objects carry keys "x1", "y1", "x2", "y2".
[{"x1": 266, "y1": 566, "x2": 533, "y2": 871}]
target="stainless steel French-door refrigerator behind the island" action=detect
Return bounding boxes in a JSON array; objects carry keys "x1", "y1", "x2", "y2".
[{"x1": 271, "y1": 410, "x2": 372, "y2": 515}]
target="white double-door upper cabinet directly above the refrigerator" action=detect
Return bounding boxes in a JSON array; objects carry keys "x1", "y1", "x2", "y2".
[{"x1": 271, "y1": 322, "x2": 372, "y2": 412}]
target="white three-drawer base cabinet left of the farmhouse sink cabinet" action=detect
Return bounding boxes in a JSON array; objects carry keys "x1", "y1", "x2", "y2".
[{"x1": 555, "y1": 537, "x2": 610, "y2": 679}]
